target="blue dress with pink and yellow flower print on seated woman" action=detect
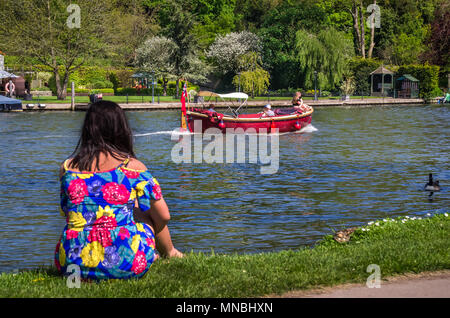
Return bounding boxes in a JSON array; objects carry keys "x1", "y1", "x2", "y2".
[{"x1": 55, "y1": 159, "x2": 162, "y2": 280}]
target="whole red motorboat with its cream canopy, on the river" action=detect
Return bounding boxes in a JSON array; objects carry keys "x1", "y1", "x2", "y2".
[{"x1": 182, "y1": 92, "x2": 314, "y2": 133}]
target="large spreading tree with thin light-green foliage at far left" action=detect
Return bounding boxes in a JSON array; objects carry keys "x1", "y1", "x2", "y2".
[{"x1": 0, "y1": 0, "x2": 107, "y2": 99}]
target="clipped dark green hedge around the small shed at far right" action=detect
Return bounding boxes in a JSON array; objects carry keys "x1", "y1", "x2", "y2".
[{"x1": 397, "y1": 64, "x2": 442, "y2": 99}]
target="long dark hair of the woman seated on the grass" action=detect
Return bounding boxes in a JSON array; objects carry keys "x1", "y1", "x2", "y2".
[{"x1": 70, "y1": 101, "x2": 136, "y2": 171}]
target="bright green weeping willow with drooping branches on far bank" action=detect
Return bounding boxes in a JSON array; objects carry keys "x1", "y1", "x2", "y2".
[{"x1": 295, "y1": 28, "x2": 353, "y2": 89}]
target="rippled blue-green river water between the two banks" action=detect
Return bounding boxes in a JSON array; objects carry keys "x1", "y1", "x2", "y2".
[{"x1": 0, "y1": 106, "x2": 450, "y2": 271}]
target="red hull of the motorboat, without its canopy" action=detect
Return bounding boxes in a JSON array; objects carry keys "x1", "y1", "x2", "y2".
[{"x1": 186, "y1": 107, "x2": 314, "y2": 133}]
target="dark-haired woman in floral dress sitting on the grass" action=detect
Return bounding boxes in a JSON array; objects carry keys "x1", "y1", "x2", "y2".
[{"x1": 55, "y1": 101, "x2": 183, "y2": 280}]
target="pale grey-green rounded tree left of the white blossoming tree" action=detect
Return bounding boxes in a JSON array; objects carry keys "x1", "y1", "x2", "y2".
[{"x1": 135, "y1": 36, "x2": 178, "y2": 96}]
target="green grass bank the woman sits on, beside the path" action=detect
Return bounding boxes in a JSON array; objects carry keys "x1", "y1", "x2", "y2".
[{"x1": 0, "y1": 213, "x2": 450, "y2": 298}]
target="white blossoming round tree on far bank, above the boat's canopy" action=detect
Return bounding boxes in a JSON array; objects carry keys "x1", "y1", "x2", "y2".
[{"x1": 206, "y1": 31, "x2": 262, "y2": 74}]
